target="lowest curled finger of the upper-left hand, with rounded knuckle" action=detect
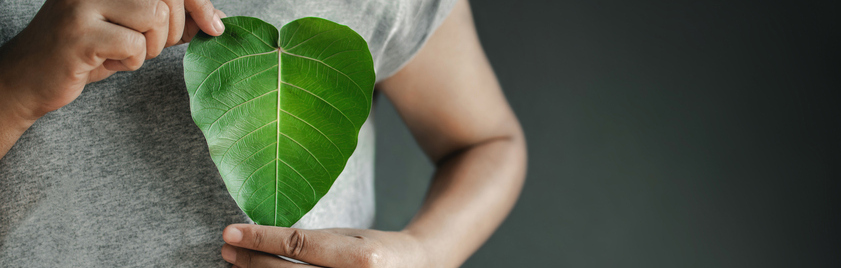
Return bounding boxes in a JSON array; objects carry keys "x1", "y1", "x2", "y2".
[{"x1": 87, "y1": 23, "x2": 146, "y2": 71}]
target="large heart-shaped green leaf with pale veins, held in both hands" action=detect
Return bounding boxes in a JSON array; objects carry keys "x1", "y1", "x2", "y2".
[{"x1": 184, "y1": 17, "x2": 375, "y2": 227}]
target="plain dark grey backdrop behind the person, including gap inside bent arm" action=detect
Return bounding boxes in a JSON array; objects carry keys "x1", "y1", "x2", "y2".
[{"x1": 376, "y1": 0, "x2": 841, "y2": 267}]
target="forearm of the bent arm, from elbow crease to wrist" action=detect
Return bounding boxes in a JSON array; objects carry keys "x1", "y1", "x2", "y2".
[{"x1": 404, "y1": 133, "x2": 526, "y2": 267}]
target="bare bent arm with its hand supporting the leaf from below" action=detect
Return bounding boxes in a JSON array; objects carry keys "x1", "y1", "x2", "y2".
[{"x1": 221, "y1": 0, "x2": 526, "y2": 268}]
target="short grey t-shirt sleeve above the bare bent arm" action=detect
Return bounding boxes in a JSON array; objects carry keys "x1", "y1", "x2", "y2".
[{"x1": 374, "y1": 0, "x2": 457, "y2": 82}]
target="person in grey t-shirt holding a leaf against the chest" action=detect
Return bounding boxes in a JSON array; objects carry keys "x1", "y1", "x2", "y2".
[{"x1": 0, "y1": 0, "x2": 526, "y2": 267}]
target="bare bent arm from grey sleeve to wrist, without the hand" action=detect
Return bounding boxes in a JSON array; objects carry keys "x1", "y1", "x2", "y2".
[{"x1": 380, "y1": 0, "x2": 526, "y2": 267}]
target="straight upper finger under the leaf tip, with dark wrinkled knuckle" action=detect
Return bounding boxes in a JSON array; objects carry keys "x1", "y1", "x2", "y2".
[{"x1": 222, "y1": 224, "x2": 382, "y2": 267}]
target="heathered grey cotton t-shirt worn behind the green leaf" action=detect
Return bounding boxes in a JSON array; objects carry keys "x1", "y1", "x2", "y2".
[{"x1": 0, "y1": 0, "x2": 454, "y2": 267}]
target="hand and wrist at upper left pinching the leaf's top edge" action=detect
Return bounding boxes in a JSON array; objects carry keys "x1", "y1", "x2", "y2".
[{"x1": 0, "y1": 0, "x2": 225, "y2": 158}]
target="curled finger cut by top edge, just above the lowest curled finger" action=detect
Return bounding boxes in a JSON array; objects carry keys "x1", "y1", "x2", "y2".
[{"x1": 100, "y1": 0, "x2": 164, "y2": 33}]
